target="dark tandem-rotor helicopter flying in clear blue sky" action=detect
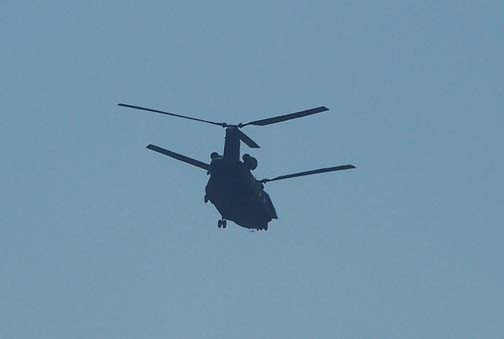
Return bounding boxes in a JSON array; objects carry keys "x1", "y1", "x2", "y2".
[{"x1": 118, "y1": 103, "x2": 355, "y2": 231}]
